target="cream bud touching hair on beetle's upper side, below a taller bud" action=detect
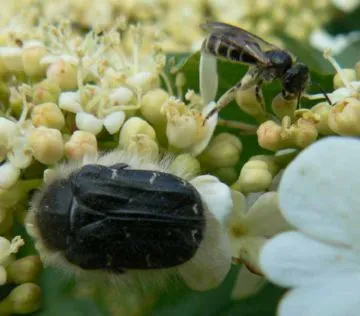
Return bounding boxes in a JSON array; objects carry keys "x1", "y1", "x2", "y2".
[{"x1": 126, "y1": 134, "x2": 159, "y2": 161}]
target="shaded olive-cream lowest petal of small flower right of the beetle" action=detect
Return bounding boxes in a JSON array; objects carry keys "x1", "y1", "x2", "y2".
[{"x1": 231, "y1": 266, "x2": 266, "y2": 300}]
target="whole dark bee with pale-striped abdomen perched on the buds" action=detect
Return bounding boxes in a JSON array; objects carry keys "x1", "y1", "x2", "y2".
[{"x1": 201, "y1": 22, "x2": 310, "y2": 119}]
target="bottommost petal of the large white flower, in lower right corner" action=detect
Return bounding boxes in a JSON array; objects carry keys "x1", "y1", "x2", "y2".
[{"x1": 278, "y1": 274, "x2": 360, "y2": 316}]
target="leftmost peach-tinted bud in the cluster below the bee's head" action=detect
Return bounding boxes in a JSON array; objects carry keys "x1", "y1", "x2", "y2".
[{"x1": 256, "y1": 120, "x2": 284, "y2": 151}]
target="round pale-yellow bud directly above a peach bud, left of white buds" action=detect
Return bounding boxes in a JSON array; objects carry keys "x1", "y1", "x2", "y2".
[{"x1": 31, "y1": 102, "x2": 65, "y2": 130}]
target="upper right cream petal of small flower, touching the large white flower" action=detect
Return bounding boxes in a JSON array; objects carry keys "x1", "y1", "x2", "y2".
[{"x1": 243, "y1": 192, "x2": 290, "y2": 237}]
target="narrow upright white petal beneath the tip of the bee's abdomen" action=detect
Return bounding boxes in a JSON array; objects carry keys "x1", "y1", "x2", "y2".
[{"x1": 199, "y1": 53, "x2": 218, "y2": 104}]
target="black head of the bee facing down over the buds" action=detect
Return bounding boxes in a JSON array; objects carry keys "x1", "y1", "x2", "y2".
[{"x1": 283, "y1": 63, "x2": 310, "y2": 95}]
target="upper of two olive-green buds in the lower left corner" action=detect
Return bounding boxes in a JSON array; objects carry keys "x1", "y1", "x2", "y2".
[{"x1": 6, "y1": 256, "x2": 42, "y2": 284}]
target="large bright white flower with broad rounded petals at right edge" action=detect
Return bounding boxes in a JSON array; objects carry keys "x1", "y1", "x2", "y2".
[{"x1": 260, "y1": 137, "x2": 360, "y2": 316}]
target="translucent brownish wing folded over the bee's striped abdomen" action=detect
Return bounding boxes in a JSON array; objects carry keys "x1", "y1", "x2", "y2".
[{"x1": 201, "y1": 22, "x2": 279, "y2": 66}]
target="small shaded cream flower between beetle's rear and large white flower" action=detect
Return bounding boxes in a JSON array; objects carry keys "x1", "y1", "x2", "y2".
[{"x1": 229, "y1": 191, "x2": 289, "y2": 299}]
